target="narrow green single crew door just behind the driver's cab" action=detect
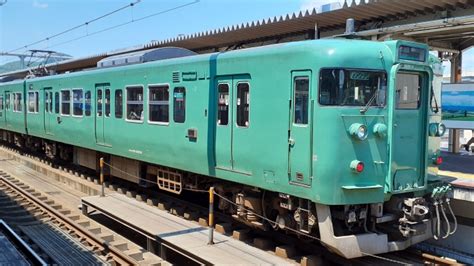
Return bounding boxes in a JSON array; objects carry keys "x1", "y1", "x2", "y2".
[{"x1": 288, "y1": 71, "x2": 313, "y2": 186}]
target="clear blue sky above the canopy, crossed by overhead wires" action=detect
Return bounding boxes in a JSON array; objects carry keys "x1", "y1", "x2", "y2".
[{"x1": 0, "y1": 0, "x2": 474, "y2": 76}]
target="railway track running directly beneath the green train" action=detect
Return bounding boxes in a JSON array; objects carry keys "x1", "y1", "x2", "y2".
[{"x1": 0, "y1": 144, "x2": 462, "y2": 265}]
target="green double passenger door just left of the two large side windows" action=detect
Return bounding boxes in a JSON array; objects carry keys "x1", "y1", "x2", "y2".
[{"x1": 95, "y1": 84, "x2": 110, "y2": 145}]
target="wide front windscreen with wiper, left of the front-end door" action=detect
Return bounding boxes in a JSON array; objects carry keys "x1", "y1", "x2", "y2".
[{"x1": 319, "y1": 69, "x2": 387, "y2": 107}]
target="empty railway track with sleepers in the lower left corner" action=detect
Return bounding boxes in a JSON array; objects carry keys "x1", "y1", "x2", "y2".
[{"x1": 0, "y1": 171, "x2": 163, "y2": 265}]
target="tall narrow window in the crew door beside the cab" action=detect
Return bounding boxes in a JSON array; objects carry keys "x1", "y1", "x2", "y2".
[{"x1": 293, "y1": 77, "x2": 309, "y2": 125}]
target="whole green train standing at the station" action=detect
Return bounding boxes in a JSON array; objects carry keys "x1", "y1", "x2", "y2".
[{"x1": 0, "y1": 39, "x2": 447, "y2": 258}]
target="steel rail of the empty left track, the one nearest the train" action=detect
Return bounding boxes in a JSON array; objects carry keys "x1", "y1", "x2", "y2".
[{"x1": 0, "y1": 171, "x2": 137, "y2": 265}]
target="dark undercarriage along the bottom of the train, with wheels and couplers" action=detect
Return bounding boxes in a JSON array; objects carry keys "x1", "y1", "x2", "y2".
[{"x1": 1, "y1": 131, "x2": 453, "y2": 258}]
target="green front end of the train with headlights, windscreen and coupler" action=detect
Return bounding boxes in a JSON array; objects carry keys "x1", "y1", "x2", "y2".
[{"x1": 314, "y1": 41, "x2": 450, "y2": 258}]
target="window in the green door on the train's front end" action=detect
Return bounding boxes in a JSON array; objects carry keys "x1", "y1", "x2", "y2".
[{"x1": 396, "y1": 73, "x2": 421, "y2": 109}]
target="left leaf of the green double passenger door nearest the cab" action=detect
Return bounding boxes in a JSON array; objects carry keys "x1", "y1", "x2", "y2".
[{"x1": 215, "y1": 76, "x2": 233, "y2": 169}]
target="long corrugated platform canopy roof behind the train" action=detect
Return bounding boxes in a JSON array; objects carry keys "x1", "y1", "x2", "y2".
[{"x1": 0, "y1": 0, "x2": 474, "y2": 78}]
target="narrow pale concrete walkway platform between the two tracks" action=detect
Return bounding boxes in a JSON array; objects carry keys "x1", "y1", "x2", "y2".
[{"x1": 81, "y1": 193, "x2": 292, "y2": 265}]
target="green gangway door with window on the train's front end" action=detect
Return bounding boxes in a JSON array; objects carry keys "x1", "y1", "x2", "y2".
[{"x1": 392, "y1": 72, "x2": 427, "y2": 190}]
